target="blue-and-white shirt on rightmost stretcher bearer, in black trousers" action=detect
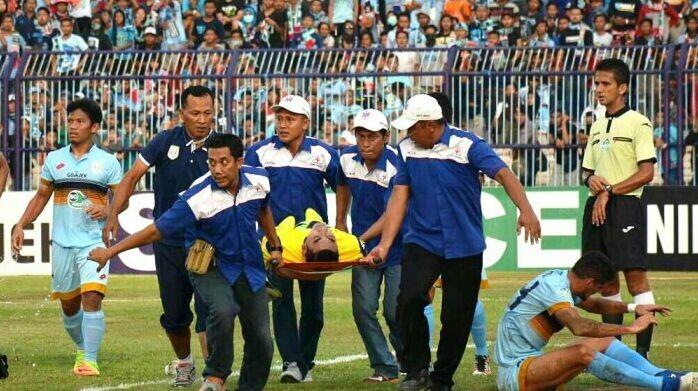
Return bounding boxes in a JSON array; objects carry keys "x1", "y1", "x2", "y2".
[{"x1": 395, "y1": 125, "x2": 506, "y2": 259}]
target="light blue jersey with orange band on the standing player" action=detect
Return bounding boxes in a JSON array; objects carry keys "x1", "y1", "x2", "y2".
[{"x1": 41, "y1": 145, "x2": 122, "y2": 248}]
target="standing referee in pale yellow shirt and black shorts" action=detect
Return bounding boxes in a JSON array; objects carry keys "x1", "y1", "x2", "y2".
[{"x1": 582, "y1": 59, "x2": 656, "y2": 358}]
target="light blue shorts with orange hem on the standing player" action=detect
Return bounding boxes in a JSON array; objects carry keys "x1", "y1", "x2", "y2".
[{"x1": 51, "y1": 242, "x2": 109, "y2": 300}]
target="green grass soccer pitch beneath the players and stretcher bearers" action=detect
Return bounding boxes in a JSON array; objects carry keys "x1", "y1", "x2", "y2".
[{"x1": 0, "y1": 272, "x2": 698, "y2": 390}]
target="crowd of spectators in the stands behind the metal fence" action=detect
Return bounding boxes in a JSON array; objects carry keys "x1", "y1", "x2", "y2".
[{"x1": 0, "y1": 0, "x2": 698, "y2": 191}]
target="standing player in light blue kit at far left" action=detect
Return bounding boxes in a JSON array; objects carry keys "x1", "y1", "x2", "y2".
[{"x1": 12, "y1": 99, "x2": 122, "y2": 376}]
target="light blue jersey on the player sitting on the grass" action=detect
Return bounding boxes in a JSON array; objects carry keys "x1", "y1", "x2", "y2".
[{"x1": 495, "y1": 270, "x2": 581, "y2": 367}]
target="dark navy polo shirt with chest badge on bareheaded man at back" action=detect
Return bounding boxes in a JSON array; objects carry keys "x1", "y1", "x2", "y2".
[{"x1": 138, "y1": 126, "x2": 208, "y2": 246}]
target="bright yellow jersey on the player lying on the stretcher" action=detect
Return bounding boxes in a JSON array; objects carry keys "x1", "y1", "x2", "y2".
[{"x1": 261, "y1": 209, "x2": 364, "y2": 263}]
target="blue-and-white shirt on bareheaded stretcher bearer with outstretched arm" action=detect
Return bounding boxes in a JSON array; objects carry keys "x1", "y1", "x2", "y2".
[{"x1": 155, "y1": 166, "x2": 269, "y2": 292}]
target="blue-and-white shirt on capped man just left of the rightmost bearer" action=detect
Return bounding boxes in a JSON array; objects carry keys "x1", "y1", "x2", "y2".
[{"x1": 337, "y1": 146, "x2": 402, "y2": 267}]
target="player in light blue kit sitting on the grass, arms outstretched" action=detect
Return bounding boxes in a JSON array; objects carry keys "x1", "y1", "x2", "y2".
[{"x1": 495, "y1": 251, "x2": 698, "y2": 391}]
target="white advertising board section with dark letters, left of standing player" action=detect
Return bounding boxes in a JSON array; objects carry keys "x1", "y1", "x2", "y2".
[{"x1": 0, "y1": 191, "x2": 53, "y2": 276}]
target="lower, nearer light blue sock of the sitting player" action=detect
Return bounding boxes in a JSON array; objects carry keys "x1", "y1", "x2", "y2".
[{"x1": 587, "y1": 352, "x2": 664, "y2": 391}]
